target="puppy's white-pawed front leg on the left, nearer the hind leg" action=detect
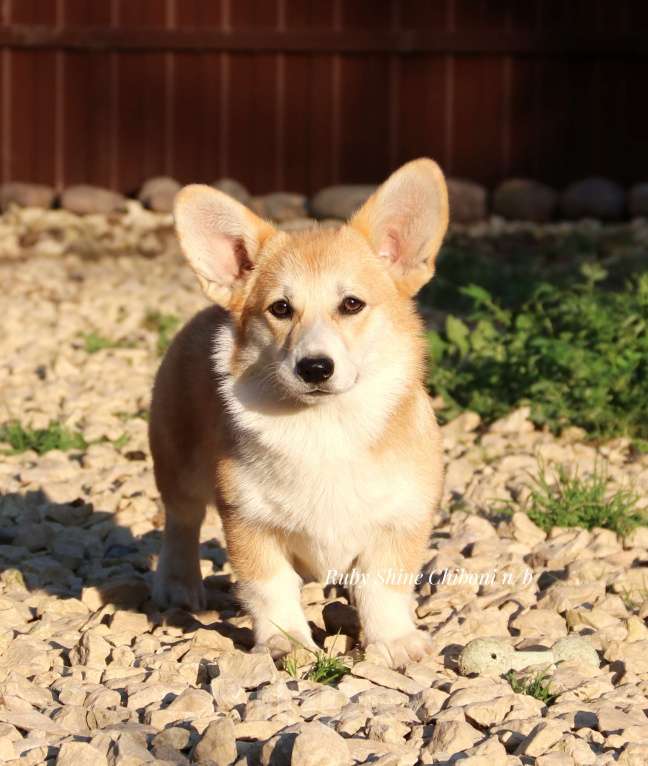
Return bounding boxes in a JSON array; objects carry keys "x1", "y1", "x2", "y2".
[{"x1": 223, "y1": 514, "x2": 317, "y2": 658}]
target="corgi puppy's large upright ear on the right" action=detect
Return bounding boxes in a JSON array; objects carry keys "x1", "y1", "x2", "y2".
[{"x1": 350, "y1": 157, "x2": 448, "y2": 295}]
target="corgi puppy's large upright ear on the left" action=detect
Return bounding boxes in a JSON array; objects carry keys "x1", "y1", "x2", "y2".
[{"x1": 174, "y1": 184, "x2": 275, "y2": 307}]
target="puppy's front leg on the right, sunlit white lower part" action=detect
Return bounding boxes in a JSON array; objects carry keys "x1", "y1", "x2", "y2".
[{"x1": 353, "y1": 523, "x2": 431, "y2": 668}]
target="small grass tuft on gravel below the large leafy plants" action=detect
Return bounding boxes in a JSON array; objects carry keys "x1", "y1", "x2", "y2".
[{"x1": 505, "y1": 466, "x2": 648, "y2": 536}]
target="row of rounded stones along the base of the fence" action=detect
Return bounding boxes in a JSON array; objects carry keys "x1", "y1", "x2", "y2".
[{"x1": 0, "y1": 176, "x2": 648, "y2": 236}]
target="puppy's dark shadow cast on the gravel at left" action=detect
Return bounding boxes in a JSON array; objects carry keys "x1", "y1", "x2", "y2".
[{"x1": 0, "y1": 490, "x2": 254, "y2": 648}]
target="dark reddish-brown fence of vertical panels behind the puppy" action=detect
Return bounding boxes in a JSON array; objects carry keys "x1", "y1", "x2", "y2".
[{"x1": 0, "y1": 0, "x2": 648, "y2": 193}]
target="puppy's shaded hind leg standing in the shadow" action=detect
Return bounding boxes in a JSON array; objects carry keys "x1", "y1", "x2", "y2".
[{"x1": 153, "y1": 497, "x2": 206, "y2": 611}]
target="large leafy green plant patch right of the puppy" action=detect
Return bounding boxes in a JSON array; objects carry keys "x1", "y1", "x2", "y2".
[{"x1": 428, "y1": 260, "x2": 648, "y2": 445}]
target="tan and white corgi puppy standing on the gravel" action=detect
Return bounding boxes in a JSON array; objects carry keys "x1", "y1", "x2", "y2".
[{"x1": 150, "y1": 159, "x2": 448, "y2": 667}]
